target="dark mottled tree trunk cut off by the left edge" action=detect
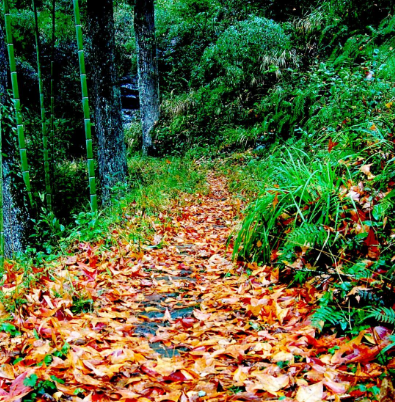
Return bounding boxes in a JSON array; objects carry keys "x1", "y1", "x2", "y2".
[{"x1": 0, "y1": 27, "x2": 29, "y2": 258}]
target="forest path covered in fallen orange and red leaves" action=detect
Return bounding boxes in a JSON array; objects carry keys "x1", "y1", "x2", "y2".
[{"x1": 0, "y1": 174, "x2": 379, "y2": 402}]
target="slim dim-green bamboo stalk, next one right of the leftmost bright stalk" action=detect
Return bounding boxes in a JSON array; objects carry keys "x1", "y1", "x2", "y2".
[{"x1": 33, "y1": 0, "x2": 52, "y2": 211}]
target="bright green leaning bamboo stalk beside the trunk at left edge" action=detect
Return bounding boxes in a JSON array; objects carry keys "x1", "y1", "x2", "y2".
[{"x1": 3, "y1": 0, "x2": 33, "y2": 205}]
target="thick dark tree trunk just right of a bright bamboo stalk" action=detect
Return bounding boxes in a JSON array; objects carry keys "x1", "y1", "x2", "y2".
[{"x1": 87, "y1": 0, "x2": 127, "y2": 204}]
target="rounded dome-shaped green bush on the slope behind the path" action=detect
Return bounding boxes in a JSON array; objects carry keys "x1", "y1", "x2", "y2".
[{"x1": 194, "y1": 17, "x2": 291, "y2": 89}]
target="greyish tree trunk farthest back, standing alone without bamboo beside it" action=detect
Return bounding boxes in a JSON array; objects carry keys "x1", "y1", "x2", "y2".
[{"x1": 134, "y1": 0, "x2": 159, "y2": 155}]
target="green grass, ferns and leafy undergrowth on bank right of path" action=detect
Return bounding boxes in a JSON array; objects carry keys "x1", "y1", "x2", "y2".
[{"x1": 229, "y1": 23, "x2": 395, "y2": 342}]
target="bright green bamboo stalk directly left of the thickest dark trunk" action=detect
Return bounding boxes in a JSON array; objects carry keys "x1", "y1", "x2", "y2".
[{"x1": 73, "y1": 0, "x2": 97, "y2": 211}]
